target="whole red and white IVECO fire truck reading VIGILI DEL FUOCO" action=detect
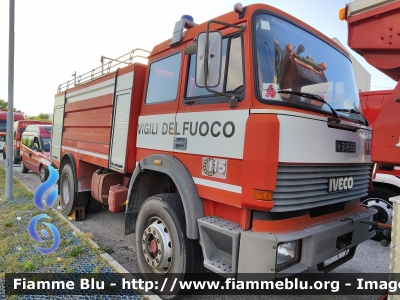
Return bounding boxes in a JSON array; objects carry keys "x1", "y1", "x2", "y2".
[{"x1": 51, "y1": 4, "x2": 376, "y2": 292}]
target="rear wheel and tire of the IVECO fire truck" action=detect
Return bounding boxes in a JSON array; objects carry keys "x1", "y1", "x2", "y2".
[{"x1": 60, "y1": 164, "x2": 90, "y2": 216}]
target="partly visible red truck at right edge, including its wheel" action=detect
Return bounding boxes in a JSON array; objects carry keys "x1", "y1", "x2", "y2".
[{"x1": 340, "y1": 0, "x2": 400, "y2": 244}]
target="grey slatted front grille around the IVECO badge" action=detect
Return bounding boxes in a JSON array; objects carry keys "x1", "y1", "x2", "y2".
[{"x1": 271, "y1": 164, "x2": 371, "y2": 212}]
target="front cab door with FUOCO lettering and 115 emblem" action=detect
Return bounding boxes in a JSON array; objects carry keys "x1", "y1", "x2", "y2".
[{"x1": 174, "y1": 30, "x2": 250, "y2": 209}]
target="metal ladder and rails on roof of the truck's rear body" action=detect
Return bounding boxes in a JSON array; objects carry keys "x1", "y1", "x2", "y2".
[{"x1": 57, "y1": 48, "x2": 150, "y2": 93}]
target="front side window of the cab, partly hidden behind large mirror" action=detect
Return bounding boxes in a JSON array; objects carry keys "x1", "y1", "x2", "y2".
[{"x1": 185, "y1": 35, "x2": 243, "y2": 98}]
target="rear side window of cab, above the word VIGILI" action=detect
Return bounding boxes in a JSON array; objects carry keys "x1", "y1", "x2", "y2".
[{"x1": 146, "y1": 52, "x2": 182, "y2": 104}]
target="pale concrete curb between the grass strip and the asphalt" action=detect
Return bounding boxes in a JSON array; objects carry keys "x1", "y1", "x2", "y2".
[{"x1": 13, "y1": 176, "x2": 162, "y2": 300}]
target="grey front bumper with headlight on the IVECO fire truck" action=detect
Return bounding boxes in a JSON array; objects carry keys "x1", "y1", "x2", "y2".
[{"x1": 238, "y1": 209, "x2": 377, "y2": 277}]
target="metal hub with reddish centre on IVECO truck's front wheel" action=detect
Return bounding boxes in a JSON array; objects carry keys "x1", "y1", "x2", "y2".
[{"x1": 142, "y1": 218, "x2": 172, "y2": 274}]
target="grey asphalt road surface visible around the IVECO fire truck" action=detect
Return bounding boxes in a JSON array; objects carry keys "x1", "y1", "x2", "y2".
[{"x1": 0, "y1": 158, "x2": 390, "y2": 300}]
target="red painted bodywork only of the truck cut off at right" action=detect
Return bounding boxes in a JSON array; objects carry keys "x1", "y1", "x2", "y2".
[{"x1": 347, "y1": 1, "x2": 400, "y2": 165}]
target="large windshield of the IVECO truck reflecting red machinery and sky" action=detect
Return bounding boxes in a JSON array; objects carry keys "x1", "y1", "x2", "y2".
[{"x1": 255, "y1": 14, "x2": 364, "y2": 122}]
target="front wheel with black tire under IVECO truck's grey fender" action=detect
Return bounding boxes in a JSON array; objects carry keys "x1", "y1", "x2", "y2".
[{"x1": 135, "y1": 194, "x2": 203, "y2": 299}]
